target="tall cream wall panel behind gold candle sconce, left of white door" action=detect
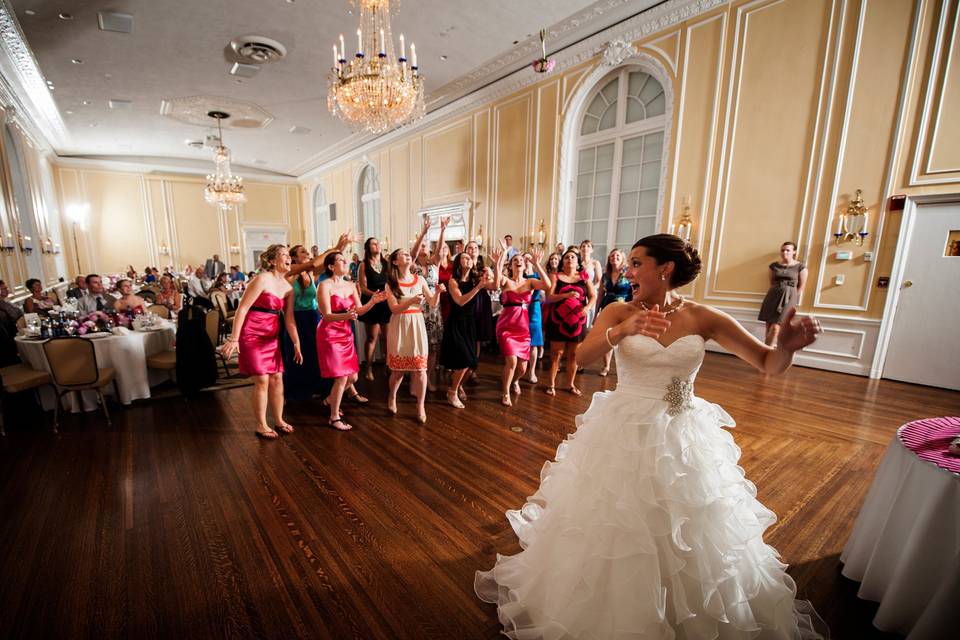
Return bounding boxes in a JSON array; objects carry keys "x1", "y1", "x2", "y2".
[{"x1": 814, "y1": 0, "x2": 913, "y2": 310}]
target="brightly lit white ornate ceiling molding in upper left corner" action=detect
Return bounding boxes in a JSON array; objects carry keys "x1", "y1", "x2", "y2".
[{"x1": 0, "y1": 0, "x2": 69, "y2": 148}]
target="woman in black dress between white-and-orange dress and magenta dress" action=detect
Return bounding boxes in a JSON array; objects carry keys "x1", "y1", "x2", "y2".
[{"x1": 440, "y1": 252, "x2": 496, "y2": 409}]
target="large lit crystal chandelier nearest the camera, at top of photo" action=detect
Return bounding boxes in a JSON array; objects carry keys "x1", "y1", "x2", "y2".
[{"x1": 327, "y1": 0, "x2": 424, "y2": 133}]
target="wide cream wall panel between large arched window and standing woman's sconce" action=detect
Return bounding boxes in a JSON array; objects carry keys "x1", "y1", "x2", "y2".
[{"x1": 707, "y1": 0, "x2": 831, "y2": 301}]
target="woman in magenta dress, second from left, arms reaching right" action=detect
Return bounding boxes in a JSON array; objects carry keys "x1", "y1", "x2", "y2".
[{"x1": 317, "y1": 251, "x2": 387, "y2": 431}]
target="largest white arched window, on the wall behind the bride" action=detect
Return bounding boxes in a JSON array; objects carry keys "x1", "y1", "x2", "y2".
[{"x1": 572, "y1": 66, "x2": 667, "y2": 262}]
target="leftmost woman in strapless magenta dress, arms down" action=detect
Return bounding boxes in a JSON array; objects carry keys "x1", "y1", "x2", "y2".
[{"x1": 223, "y1": 244, "x2": 303, "y2": 439}]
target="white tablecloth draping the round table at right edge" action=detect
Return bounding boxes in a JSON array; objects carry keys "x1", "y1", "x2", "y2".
[{"x1": 840, "y1": 438, "x2": 960, "y2": 640}]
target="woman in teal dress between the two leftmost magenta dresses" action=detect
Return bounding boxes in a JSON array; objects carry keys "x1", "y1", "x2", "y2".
[{"x1": 283, "y1": 245, "x2": 331, "y2": 400}]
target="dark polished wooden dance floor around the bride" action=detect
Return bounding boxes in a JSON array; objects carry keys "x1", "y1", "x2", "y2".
[{"x1": 0, "y1": 354, "x2": 960, "y2": 639}]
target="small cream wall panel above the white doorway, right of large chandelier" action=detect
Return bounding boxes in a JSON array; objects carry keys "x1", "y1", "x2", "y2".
[{"x1": 423, "y1": 117, "x2": 473, "y2": 205}]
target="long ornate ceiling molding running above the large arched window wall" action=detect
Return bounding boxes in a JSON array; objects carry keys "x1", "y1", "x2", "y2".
[{"x1": 290, "y1": 0, "x2": 729, "y2": 180}]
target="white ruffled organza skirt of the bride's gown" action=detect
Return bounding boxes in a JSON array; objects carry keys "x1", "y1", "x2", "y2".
[{"x1": 474, "y1": 391, "x2": 829, "y2": 640}]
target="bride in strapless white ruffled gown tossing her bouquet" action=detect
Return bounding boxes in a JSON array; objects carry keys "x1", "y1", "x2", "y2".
[{"x1": 474, "y1": 234, "x2": 829, "y2": 640}]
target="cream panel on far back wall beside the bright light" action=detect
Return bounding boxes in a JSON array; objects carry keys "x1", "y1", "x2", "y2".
[{"x1": 80, "y1": 171, "x2": 150, "y2": 273}]
